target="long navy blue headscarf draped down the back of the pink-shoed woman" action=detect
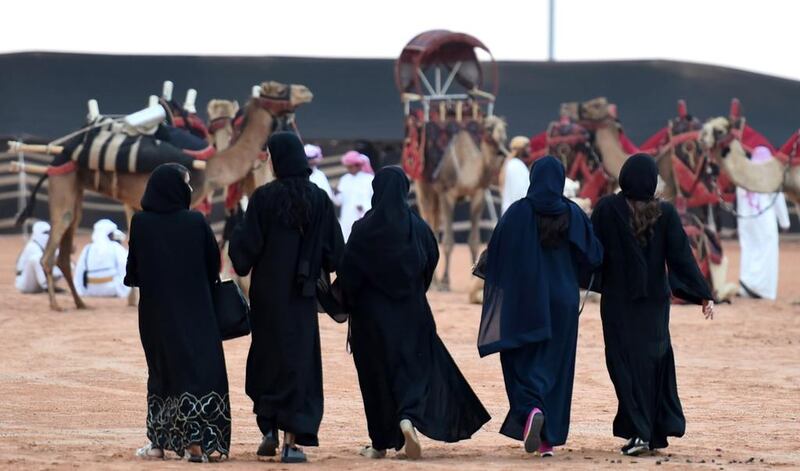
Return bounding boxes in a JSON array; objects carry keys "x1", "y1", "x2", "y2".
[{"x1": 478, "y1": 156, "x2": 603, "y2": 356}]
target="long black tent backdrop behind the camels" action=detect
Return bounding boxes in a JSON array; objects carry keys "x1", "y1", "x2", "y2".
[{"x1": 0, "y1": 53, "x2": 800, "y2": 235}]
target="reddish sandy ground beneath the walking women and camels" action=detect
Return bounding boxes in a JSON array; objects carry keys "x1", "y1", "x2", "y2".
[{"x1": 0, "y1": 237, "x2": 800, "y2": 470}]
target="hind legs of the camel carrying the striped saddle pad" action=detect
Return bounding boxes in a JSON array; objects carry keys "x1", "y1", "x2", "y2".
[{"x1": 40, "y1": 172, "x2": 79, "y2": 311}]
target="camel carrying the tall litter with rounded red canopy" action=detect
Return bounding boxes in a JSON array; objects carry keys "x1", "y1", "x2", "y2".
[{"x1": 415, "y1": 116, "x2": 508, "y2": 291}]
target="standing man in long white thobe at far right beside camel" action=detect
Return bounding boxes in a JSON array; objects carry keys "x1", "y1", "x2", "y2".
[{"x1": 736, "y1": 146, "x2": 789, "y2": 300}]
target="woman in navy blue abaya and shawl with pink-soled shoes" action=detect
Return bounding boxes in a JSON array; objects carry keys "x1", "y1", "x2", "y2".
[{"x1": 478, "y1": 156, "x2": 602, "y2": 456}]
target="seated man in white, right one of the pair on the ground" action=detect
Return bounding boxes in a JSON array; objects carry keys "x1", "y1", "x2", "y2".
[{"x1": 74, "y1": 219, "x2": 131, "y2": 298}]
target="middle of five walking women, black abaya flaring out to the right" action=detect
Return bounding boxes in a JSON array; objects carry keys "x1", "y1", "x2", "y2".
[{"x1": 337, "y1": 167, "x2": 489, "y2": 459}]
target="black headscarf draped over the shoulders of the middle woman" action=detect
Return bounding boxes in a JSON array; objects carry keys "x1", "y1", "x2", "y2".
[{"x1": 342, "y1": 166, "x2": 427, "y2": 299}]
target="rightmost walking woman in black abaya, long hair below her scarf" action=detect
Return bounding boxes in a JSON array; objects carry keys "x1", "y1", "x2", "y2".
[{"x1": 592, "y1": 154, "x2": 713, "y2": 455}]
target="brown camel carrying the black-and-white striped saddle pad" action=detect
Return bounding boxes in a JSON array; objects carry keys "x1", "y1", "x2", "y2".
[{"x1": 22, "y1": 82, "x2": 313, "y2": 311}]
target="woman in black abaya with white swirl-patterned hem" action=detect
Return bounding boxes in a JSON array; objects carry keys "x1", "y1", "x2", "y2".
[{"x1": 125, "y1": 164, "x2": 231, "y2": 461}]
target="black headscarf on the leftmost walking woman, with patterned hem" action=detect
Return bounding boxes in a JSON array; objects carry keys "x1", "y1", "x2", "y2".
[{"x1": 141, "y1": 163, "x2": 192, "y2": 213}]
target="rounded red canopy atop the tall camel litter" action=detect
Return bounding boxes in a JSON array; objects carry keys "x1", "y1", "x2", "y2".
[{"x1": 395, "y1": 29, "x2": 497, "y2": 94}]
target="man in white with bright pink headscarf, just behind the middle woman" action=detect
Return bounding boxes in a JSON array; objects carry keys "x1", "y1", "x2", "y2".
[{"x1": 336, "y1": 151, "x2": 374, "y2": 242}]
